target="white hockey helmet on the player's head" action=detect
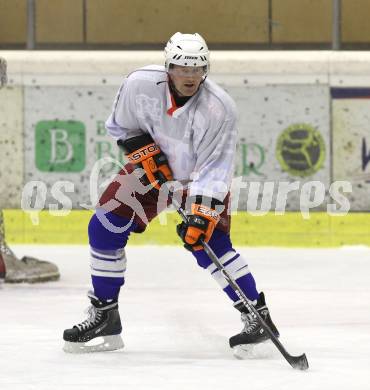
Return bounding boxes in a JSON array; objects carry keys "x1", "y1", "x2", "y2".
[{"x1": 164, "y1": 32, "x2": 209, "y2": 75}]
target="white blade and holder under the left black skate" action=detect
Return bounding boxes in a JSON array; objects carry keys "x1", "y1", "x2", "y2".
[{"x1": 63, "y1": 335, "x2": 124, "y2": 353}]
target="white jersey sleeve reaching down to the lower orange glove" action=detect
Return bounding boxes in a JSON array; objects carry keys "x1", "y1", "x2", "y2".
[{"x1": 189, "y1": 106, "x2": 237, "y2": 202}]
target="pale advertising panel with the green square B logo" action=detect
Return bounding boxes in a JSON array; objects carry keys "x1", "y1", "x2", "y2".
[{"x1": 25, "y1": 86, "x2": 123, "y2": 209}]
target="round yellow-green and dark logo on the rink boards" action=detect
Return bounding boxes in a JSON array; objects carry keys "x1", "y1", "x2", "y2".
[{"x1": 276, "y1": 123, "x2": 325, "y2": 177}]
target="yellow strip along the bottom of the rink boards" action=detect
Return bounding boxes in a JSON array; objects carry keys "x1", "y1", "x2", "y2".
[{"x1": 4, "y1": 210, "x2": 370, "y2": 247}]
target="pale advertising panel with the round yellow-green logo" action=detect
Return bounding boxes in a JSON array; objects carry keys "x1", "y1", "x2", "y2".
[{"x1": 226, "y1": 85, "x2": 330, "y2": 210}]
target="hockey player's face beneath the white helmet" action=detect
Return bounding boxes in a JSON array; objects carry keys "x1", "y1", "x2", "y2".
[{"x1": 168, "y1": 65, "x2": 205, "y2": 96}]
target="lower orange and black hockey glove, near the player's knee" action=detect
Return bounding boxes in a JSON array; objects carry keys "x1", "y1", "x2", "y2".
[{"x1": 177, "y1": 203, "x2": 220, "y2": 251}]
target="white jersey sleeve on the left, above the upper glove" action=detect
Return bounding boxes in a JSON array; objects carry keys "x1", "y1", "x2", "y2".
[{"x1": 105, "y1": 78, "x2": 143, "y2": 140}]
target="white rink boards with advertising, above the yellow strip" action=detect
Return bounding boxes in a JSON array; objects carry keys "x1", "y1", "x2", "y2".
[{"x1": 0, "y1": 51, "x2": 370, "y2": 211}]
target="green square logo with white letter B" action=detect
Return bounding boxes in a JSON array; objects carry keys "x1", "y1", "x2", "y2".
[{"x1": 35, "y1": 120, "x2": 86, "y2": 172}]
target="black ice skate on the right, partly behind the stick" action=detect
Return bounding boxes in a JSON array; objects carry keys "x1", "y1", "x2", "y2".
[{"x1": 229, "y1": 292, "x2": 279, "y2": 358}]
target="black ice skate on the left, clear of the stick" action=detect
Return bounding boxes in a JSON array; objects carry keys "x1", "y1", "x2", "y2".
[{"x1": 63, "y1": 292, "x2": 123, "y2": 353}]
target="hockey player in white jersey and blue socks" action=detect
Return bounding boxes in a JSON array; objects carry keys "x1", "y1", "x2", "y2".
[{"x1": 63, "y1": 32, "x2": 279, "y2": 352}]
